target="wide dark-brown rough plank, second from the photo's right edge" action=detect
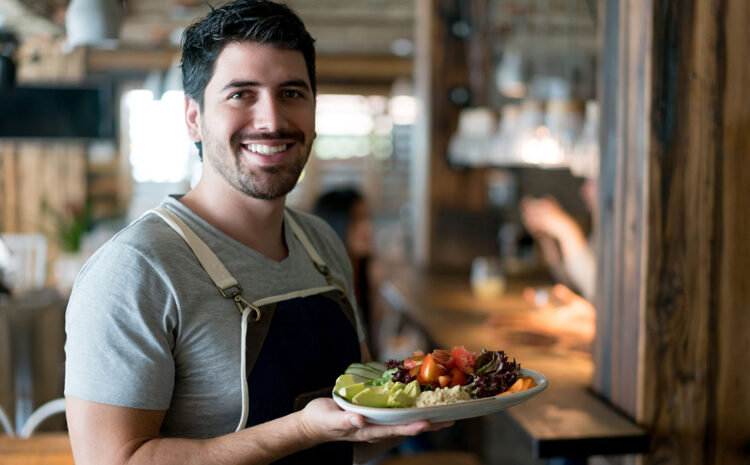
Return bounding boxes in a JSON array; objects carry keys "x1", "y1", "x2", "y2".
[{"x1": 643, "y1": 1, "x2": 728, "y2": 464}]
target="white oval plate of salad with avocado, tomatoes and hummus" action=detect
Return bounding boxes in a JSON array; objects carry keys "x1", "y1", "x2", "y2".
[{"x1": 333, "y1": 346, "x2": 548, "y2": 424}]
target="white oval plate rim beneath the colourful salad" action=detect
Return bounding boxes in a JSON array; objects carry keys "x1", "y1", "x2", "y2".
[{"x1": 333, "y1": 368, "x2": 549, "y2": 425}]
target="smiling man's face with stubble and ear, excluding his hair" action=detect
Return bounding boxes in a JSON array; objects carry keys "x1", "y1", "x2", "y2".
[{"x1": 186, "y1": 42, "x2": 315, "y2": 200}]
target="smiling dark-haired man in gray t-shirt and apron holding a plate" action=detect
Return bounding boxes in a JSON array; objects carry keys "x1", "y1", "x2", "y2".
[{"x1": 65, "y1": 0, "x2": 445, "y2": 465}]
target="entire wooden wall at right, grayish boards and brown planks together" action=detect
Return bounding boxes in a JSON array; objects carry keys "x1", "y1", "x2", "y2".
[{"x1": 595, "y1": 0, "x2": 750, "y2": 465}]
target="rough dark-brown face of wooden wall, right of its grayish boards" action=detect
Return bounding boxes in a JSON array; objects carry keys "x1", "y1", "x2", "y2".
[{"x1": 642, "y1": 0, "x2": 750, "y2": 465}]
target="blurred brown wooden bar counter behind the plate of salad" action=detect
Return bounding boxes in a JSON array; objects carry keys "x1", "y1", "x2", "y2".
[{"x1": 380, "y1": 266, "x2": 648, "y2": 458}]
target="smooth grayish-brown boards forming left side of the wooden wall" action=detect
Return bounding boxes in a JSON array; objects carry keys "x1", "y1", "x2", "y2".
[{"x1": 592, "y1": 0, "x2": 651, "y2": 418}]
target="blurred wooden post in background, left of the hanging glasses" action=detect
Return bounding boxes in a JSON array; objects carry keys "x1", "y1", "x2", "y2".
[{"x1": 410, "y1": 0, "x2": 494, "y2": 268}]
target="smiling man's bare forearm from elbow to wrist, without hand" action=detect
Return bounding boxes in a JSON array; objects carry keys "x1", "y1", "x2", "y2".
[{"x1": 123, "y1": 413, "x2": 317, "y2": 465}]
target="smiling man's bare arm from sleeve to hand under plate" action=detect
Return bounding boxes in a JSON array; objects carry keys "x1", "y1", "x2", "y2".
[{"x1": 66, "y1": 397, "x2": 446, "y2": 465}]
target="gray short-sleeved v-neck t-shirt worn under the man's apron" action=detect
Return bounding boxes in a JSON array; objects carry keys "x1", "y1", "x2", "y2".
[{"x1": 65, "y1": 197, "x2": 364, "y2": 438}]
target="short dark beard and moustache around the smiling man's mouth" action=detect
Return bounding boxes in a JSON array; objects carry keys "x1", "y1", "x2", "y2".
[{"x1": 203, "y1": 132, "x2": 312, "y2": 200}]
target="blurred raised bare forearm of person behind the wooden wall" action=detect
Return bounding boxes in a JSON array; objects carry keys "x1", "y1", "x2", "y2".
[{"x1": 521, "y1": 179, "x2": 596, "y2": 300}]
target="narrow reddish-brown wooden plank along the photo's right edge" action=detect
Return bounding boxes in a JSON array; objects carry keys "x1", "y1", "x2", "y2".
[{"x1": 711, "y1": 0, "x2": 750, "y2": 465}]
